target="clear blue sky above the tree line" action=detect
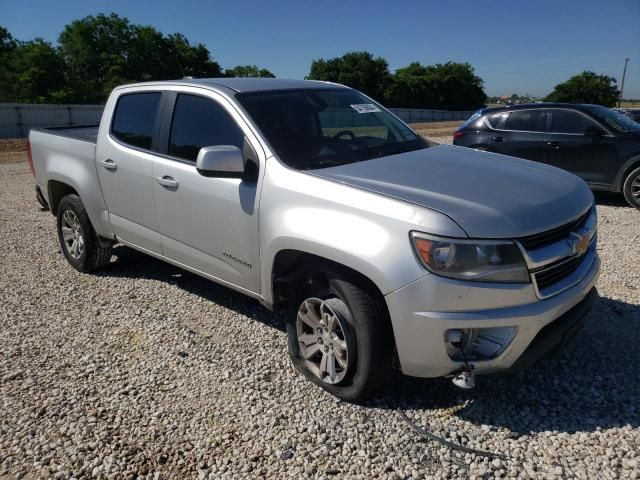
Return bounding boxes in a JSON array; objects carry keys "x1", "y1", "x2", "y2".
[{"x1": 0, "y1": 0, "x2": 640, "y2": 98}]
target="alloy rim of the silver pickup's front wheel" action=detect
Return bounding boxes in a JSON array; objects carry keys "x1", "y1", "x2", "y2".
[{"x1": 296, "y1": 298, "x2": 349, "y2": 384}]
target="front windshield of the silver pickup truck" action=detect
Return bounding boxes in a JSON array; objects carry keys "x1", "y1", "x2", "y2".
[{"x1": 237, "y1": 88, "x2": 429, "y2": 170}]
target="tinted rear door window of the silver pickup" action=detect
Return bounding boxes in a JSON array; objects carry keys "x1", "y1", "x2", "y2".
[{"x1": 111, "y1": 92, "x2": 161, "y2": 150}]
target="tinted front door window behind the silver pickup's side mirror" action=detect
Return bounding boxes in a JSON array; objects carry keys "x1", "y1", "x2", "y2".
[{"x1": 169, "y1": 94, "x2": 244, "y2": 162}]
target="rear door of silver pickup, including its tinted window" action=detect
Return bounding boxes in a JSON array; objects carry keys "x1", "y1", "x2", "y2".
[{"x1": 96, "y1": 90, "x2": 162, "y2": 253}]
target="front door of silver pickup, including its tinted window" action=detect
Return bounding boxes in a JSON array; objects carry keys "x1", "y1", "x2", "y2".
[{"x1": 153, "y1": 93, "x2": 260, "y2": 293}]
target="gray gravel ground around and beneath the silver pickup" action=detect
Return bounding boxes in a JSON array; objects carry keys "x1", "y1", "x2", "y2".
[{"x1": 0, "y1": 163, "x2": 640, "y2": 479}]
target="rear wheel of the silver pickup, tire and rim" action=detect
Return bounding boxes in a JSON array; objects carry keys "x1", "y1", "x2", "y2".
[{"x1": 56, "y1": 195, "x2": 111, "y2": 272}]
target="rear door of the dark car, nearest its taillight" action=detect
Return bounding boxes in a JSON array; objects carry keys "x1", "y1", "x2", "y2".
[{"x1": 487, "y1": 109, "x2": 548, "y2": 162}]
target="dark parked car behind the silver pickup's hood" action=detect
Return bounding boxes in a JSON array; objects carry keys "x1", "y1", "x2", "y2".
[{"x1": 453, "y1": 103, "x2": 640, "y2": 208}]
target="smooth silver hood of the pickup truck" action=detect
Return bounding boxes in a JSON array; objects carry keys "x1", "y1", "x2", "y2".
[{"x1": 310, "y1": 145, "x2": 593, "y2": 238}]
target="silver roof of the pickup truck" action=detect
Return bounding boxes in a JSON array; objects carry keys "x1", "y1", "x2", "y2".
[{"x1": 115, "y1": 78, "x2": 347, "y2": 92}]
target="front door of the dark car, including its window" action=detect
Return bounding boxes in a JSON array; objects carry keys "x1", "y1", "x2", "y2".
[{"x1": 547, "y1": 108, "x2": 618, "y2": 186}]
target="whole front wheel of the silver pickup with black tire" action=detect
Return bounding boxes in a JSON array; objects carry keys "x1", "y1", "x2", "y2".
[{"x1": 287, "y1": 274, "x2": 393, "y2": 402}]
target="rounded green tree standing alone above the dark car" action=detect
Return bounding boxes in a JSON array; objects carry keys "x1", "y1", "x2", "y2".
[{"x1": 545, "y1": 70, "x2": 620, "y2": 107}]
